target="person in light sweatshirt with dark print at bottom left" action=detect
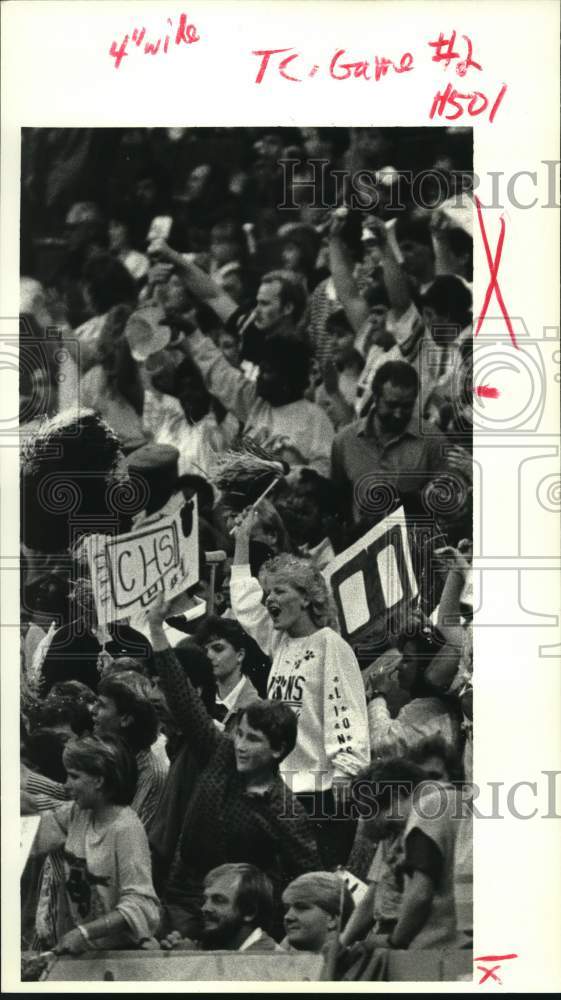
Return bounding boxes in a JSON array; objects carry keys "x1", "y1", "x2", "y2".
[{"x1": 24, "y1": 736, "x2": 159, "y2": 955}]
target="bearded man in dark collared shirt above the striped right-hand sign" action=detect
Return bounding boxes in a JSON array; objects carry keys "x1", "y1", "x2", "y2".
[{"x1": 331, "y1": 361, "x2": 446, "y2": 525}]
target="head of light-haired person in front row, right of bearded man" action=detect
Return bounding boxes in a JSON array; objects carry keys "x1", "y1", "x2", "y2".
[{"x1": 282, "y1": 872, "x2": 353, "y2": 953}]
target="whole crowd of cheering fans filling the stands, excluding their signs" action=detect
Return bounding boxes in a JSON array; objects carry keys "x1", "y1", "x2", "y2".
[{"x1": 20, "y1": 128, "x2": 472, "y2": 979}]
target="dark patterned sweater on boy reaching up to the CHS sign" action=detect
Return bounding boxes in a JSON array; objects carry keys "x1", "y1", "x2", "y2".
[{"x1": 154, "y1": 649, "x2": 321, "y2": 937}]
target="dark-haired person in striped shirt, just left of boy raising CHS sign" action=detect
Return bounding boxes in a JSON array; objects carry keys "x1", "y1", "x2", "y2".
[{"x1": 93, "y1": 671, "x2": 168, "y2": 826}]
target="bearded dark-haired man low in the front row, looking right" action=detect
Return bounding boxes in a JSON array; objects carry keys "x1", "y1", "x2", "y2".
[{"x1": 161, "y1": 863, "x2": 283, "y2": 952}]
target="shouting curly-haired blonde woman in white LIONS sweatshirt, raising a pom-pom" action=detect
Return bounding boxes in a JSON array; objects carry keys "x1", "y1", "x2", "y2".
[{"x1": 230, "y1": 512, "x2": 370, "y2": 867}]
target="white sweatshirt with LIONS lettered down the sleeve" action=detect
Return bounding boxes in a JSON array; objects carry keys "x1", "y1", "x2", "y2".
[{"x1": 230, "y1": 566, "x2": 370, "y2": 794}]
